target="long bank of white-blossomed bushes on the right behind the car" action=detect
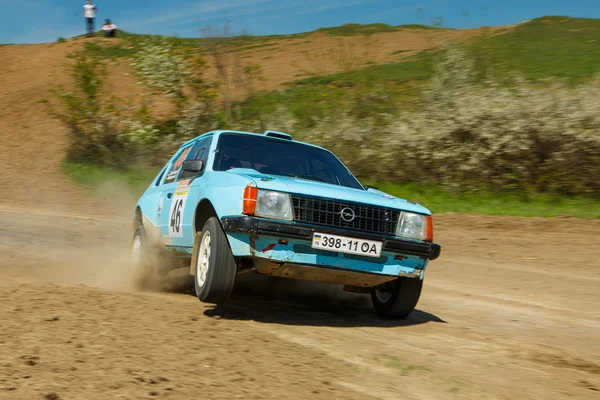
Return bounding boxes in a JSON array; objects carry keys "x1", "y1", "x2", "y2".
[{"x1": 304, "y1": 48, "x2": 600, "y2": 197}]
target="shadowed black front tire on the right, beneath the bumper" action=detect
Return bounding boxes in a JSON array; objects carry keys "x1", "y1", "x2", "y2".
[{"x1": 371, "y1": 278, "x2": 423, "y2": 319}]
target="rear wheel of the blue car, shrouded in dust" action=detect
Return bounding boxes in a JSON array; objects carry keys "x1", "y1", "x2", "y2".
[{"x1": 132, "y1": 225, "x2": 166, "y2": 289}]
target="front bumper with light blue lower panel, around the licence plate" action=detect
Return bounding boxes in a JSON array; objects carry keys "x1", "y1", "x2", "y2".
[{"x1": 221, "y1": 216, "x2": 441, "y2": 279}]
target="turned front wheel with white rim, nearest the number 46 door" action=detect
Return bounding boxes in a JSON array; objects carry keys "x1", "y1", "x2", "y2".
[{"x1": 192, "y1": 217, "x2": 237, "y2": 304}]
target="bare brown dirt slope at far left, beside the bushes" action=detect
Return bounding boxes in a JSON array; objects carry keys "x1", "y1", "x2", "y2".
[{"x1": 0, "y1": 44, "x2": 94, "y2": 212}]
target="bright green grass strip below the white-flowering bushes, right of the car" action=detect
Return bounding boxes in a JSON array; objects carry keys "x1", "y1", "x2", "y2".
[{"x1": 375, "y1": 184, "x2": 600, "y2": 218}]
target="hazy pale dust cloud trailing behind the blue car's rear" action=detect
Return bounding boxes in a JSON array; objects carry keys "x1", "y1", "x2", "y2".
[{"x1": 0, "y1": 181, "x2": 142, "y2": 291}]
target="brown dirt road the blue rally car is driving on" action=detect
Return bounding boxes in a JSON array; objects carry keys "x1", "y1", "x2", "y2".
[{"x1": 0, "y1": 206, "x2": 600, "y2": 399}]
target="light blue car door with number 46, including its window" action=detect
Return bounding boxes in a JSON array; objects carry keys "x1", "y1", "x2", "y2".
[{"x1": 161, "y1": 136, "x2": 212, "y2": 247}]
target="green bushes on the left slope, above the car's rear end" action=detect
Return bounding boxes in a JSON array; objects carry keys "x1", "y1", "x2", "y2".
[{"x1": 50, "y1": 38, "x2": 217, "y2": 167}]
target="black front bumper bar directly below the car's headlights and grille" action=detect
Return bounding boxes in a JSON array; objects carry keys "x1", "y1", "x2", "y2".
[{"x1": 221, "y1": 216, "x2": 441, "y2": 260}]
